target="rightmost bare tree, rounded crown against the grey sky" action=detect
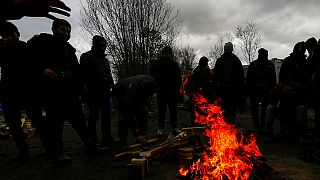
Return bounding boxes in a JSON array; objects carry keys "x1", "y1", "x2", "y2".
[{"x1": 235, "y1": 21, "x2": 262, "y2": 63}]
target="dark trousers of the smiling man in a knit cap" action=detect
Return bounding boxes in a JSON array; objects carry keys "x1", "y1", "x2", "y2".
[{"x1": 45, "y1": 95, "x2": 89, "y2": 153}]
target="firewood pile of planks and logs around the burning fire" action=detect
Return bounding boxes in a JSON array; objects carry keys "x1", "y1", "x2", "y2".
[{"x1": 115, "y1": 127, "x2": 276, "y2": 179}]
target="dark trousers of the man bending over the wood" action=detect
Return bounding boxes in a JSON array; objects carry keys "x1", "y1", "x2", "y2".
[{"x1": 118, "y1": 105, "x2": 148, "y2": 143}]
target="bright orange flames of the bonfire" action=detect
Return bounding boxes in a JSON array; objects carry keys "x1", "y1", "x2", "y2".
[{"x1": 179, "y1": 95, "x2": 262, "y2": 180}]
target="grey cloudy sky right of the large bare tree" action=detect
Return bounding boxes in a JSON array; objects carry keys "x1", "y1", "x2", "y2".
[{"x1": 170, "y1": 0, "x2": 320, "y2": 58}]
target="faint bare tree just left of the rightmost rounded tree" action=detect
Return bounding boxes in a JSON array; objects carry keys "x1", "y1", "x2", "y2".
[{"x1": 208, "y1": 33, "x2": 234, "y2": 67}]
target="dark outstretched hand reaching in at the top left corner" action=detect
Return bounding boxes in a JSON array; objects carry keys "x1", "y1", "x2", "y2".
[{"x1": 14, "y1": 0, "x2": 71, "y2": 20}]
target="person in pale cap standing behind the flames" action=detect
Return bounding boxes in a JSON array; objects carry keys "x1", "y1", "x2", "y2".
[{"x1": 213, "y1": 42, "x2": 244, "y2": 124}]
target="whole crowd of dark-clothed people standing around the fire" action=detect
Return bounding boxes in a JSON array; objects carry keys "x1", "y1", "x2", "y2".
[{"x1": 0, "y1": 0, "x2": 320, "y2": 167}]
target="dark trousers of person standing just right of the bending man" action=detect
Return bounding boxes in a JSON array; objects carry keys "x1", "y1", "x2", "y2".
[{"x1": 157, "y1": 93, "x2": 178, "y2": 129}]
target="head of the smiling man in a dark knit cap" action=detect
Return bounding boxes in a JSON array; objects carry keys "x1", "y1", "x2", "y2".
[{"x1": 51, "y1": 19, "x2": 71, "y2": 42}]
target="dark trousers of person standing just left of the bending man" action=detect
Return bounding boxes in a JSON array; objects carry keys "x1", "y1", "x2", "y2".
[{"x1": 88, "y1": 96, "x2": 111, "y2": 144}]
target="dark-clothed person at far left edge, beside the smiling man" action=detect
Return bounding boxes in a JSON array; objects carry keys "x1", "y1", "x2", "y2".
[{"x1": 0, "y1": 22, "x2": 44, "y2": 161}]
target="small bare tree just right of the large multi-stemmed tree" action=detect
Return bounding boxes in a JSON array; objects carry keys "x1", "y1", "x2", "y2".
[{"x1": 175, "y1": 45, "x2": 196, "y2": 73}]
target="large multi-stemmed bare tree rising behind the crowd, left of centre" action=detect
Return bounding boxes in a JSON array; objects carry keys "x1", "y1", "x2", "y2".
[{"x1": 80, "y1": 0, "x2": 181, "y2": 78}]
